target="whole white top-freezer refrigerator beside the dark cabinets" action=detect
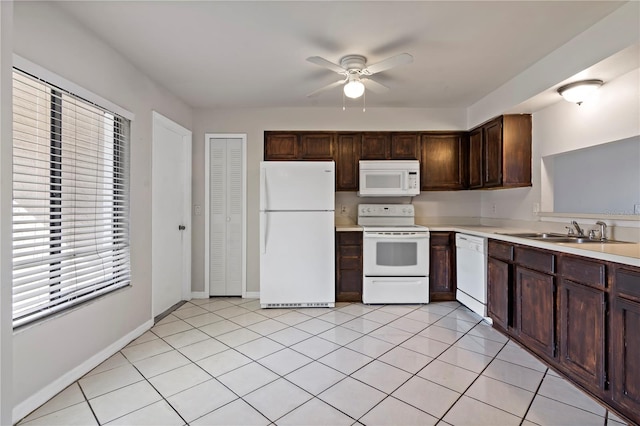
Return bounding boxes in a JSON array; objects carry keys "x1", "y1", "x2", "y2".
[{"x1": 260, "y1": 161, "x2": 335, "y2": 308}]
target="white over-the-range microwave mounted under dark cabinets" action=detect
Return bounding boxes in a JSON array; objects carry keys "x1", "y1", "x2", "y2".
[{"x1": 358, "y1": 160, "x2": 420, "y2": 197}]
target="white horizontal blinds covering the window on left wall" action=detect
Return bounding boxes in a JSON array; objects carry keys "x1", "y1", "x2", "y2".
[{"x1": 13, "y1": 70, "x2": 130, "y2": 327}]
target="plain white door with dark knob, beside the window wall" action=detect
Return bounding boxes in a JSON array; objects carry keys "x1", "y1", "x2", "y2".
[{"x1": 151, "y1": 111, "x2": 191, "y2": 317}]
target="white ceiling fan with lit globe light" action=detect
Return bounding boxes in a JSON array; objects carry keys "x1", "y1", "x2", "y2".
[{"x1": 307, "y1": 53, "x2": 413, "y2": 99}]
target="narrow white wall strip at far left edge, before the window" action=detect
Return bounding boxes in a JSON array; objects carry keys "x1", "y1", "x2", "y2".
[{"x1": 0, "y1": 1, "x2": 13, "y2": 425}]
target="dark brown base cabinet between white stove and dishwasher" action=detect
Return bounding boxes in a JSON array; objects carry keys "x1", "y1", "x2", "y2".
[{"x1": 429, "y1": 232, "x2": 456, "y2": 301}]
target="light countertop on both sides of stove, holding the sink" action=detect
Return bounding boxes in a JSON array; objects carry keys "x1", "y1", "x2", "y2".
[{"x1": 336, "y1": 224, "x2": 640, "y2": 267}]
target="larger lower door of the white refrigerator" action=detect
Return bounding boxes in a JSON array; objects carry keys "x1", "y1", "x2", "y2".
[{"x1": 260, "y1": 212, "x2": 335, "y2": 308}]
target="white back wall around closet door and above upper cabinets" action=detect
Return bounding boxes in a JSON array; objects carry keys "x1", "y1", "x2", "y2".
[{"x1": 191, "y1": 105, "x2": 466, "y2": 292}]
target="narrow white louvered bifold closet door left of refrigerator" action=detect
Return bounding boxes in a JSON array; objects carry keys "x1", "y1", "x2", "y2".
[{"x1": 205, "y1": 134, "x2": 246, "y2": 296}]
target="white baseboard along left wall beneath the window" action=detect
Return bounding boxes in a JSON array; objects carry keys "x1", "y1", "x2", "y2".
[{"x1": 11, "y1": 319, "x2": 153, "y2": 423}]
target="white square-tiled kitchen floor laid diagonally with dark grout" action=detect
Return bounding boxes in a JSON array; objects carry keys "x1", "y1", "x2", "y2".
[{"x1": 20, "y1": 298, "x2": 623, "y2": 426}]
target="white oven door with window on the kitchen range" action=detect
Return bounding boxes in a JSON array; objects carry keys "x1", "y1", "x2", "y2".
[{"x1": 363, "y1": 231, "x2": 429, "y2": 277}]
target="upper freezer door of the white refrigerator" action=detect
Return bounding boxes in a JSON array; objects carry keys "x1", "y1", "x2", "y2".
[{"x1": 260, "y1": 161, "x2": 335, "y2": 211}]
